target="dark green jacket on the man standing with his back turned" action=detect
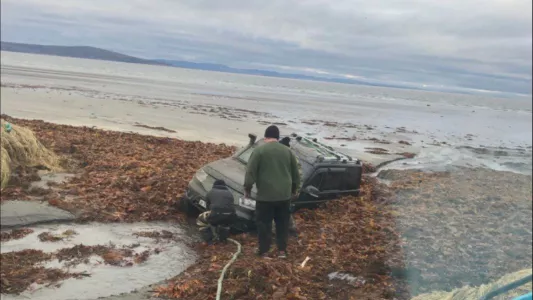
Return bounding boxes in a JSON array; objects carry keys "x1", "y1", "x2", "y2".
[{"x1": 244, "y1": 142, "x2": 300, "y2": 201}]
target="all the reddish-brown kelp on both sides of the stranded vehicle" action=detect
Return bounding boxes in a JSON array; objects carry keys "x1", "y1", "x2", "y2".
[{"x1": 2, "y1": 116, "x2": 409, "y2": 299}]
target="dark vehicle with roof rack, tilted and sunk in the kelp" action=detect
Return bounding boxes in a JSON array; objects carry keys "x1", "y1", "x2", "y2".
[{"x1": 179, "y1": 134, "x2": 363, "y2": 231}]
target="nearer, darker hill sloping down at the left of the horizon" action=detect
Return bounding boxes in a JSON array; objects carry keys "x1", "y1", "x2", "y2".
[{"x1": 1, "y1": 42, "x2": 164, "y2": 65}]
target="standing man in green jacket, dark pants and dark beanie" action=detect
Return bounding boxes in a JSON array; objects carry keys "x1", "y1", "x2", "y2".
[{"x1": 244, "y1": 126, "x2": 300, "y2": 258}]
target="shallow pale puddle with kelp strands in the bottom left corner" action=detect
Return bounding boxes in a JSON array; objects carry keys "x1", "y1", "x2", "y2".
[{"x1": 0, "y1": 222, "x2": 196, "y2": 300}]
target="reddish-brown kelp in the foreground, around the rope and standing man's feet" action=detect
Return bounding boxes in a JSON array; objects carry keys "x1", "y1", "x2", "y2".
[{"x1": 156, "y1": 178, "x2": 409, "y2": 299}]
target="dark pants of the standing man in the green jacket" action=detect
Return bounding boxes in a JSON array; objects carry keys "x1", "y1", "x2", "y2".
[{"x1": 255, "y1": 200, "x2": 290, "y2": 254}]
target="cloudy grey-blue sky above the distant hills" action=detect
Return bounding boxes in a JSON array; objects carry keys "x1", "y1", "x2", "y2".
[{"x1": 1, "y1": 0, "x2": 532, "y2": 97}]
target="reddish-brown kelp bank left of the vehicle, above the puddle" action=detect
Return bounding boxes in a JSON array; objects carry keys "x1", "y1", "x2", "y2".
[{"x1": 1, "y1": 116, "x2": 235, "y2": 222}]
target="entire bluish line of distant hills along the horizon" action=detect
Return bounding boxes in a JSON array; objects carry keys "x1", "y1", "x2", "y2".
[{"x1": 1, "y1": 42, "x2": 405, "y2": 88}]
